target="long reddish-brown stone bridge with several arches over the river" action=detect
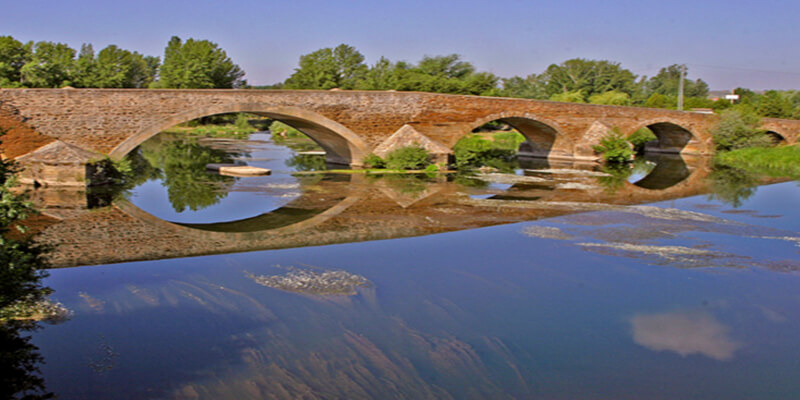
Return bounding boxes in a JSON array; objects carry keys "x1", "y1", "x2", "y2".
[{"x1": 0, "y1": 88, "x2": 800, "y2": 181}]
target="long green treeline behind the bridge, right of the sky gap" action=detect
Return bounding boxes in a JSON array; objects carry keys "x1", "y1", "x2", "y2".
[{"x1": 270, "y1": 44, "x2": 800, "y2": 118}]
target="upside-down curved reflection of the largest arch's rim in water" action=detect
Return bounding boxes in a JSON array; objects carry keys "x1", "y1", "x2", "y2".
[{"x1": 114, "y1": 175, "x2": 364, "y2": 240}]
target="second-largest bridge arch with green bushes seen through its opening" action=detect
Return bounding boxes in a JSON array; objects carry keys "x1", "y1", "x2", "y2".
[{"x1": 460, "y1": 114, "x2": 572, "y2": 166}]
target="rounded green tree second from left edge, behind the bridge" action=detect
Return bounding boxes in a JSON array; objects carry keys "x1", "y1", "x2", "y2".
[{"x1": 20, "y1": 42, "x2": 75, "y2": 88}]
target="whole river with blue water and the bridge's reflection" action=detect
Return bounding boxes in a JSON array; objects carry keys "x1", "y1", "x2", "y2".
[{"x1": 14, "y1": 134, "x2": 800, "y2": 399}]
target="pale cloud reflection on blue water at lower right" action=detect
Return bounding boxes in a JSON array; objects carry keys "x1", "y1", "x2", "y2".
[{"x1": 631, "y1": 311, "x2": 741, "y2": 361}]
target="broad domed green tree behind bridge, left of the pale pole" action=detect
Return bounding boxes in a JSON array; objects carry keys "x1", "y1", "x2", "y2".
[{"x1": 539, "y1": 58, "x2": 637, "y2": 101}]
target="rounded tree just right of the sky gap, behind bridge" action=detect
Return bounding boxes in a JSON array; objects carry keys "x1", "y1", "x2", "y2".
[{"x1": 284, "y1": 44, "x2": 368, "y2": 90}]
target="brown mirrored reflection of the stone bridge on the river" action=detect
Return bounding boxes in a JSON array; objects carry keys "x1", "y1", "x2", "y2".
[{"x1": 20, "y1": 156, "x2": 710, "y2": 267}]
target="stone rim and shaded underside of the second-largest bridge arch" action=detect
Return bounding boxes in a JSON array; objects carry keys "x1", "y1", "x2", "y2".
[{"x1": 469, "y1": 112, "x2": 574, "y2": 159}]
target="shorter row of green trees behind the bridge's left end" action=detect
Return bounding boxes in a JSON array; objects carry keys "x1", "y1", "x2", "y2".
[{"x1": 0, "y1": 36, "x2": 246, "y2": 89}]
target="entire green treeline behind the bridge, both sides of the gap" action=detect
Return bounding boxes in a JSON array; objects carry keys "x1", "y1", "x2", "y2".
[{"x1": 0, "y1": 36, "x2": 800, "y2": 119}]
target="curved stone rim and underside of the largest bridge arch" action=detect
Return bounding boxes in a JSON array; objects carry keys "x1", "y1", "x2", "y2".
[{"x1": 109, "y1": 103, "x2": 369, "y2": 165}]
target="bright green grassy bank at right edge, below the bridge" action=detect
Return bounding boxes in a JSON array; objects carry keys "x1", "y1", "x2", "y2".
[{"x1": 715, "y1": 145, "x2": 800, "y2": 179}]
